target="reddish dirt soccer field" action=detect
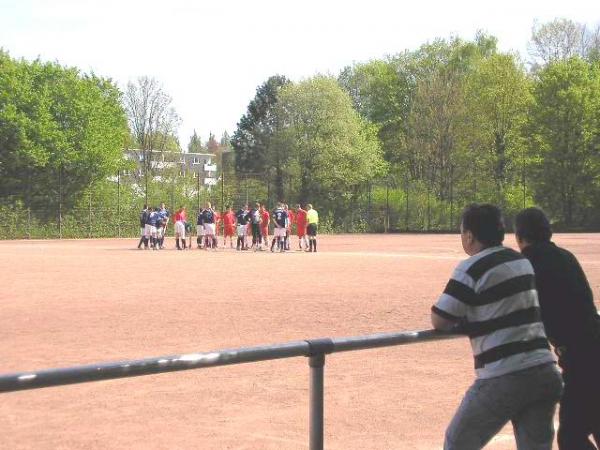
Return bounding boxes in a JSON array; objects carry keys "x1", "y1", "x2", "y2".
[{"x1": 0, "y1": 234, "x2": 600, "y2": 450}]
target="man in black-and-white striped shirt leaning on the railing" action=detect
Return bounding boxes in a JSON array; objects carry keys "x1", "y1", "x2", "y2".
[{"x1": 431, "y1": 204, "x2": 562, "y2": 450}]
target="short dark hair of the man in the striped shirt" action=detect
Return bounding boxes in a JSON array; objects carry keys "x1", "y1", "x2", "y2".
[{"x1": 462, "y1": 203, "x2": 504, "y2": 247}]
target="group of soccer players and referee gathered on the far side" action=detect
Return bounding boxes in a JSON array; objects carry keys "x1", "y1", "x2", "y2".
[{"x1": 138, "y1": 202, "x2": 319, "y2": 252}]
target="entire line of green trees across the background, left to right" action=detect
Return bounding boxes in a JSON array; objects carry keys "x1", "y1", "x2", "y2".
[{"x1": 0, "y1": 19, "x2": 600, "y2": 236}]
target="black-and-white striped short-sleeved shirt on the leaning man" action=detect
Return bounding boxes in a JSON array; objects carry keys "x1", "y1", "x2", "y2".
[{"x1": 432, "y1": 246, "x2": 555, "y2": 378}]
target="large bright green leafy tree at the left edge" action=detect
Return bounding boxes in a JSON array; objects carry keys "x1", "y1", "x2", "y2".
[{"x1": 0, "y1": 51, "x2": 128, "y2": 215}]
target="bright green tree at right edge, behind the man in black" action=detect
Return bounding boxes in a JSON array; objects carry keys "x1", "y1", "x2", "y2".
[{"x1": 530, "y1": 57, "x2": 600, "y2": 227}]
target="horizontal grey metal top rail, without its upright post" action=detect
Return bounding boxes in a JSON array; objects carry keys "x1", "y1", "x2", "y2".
[{"x1": 0, "y1": 330, "x2": 459, "y2": 393}]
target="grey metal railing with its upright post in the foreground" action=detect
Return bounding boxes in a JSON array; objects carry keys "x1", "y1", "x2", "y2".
[{"x1": 0, "y1": 330, "x2": 460, "y2": 450}]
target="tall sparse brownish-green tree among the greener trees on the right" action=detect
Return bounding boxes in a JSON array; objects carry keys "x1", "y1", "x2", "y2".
[{"x1": 403, "y1": 38, "x2": 482, "y2": 200}]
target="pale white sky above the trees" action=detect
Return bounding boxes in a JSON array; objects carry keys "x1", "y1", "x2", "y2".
[{"x1": 0, "y1": 0, "x2": 600, "y2": 148}]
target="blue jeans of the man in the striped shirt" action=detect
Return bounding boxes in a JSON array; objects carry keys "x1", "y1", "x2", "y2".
[{"x1": 444, "y1": 363, "x2": 563, "y2": 450}]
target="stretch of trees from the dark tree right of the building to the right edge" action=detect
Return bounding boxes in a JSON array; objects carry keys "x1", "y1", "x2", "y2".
[{"x1": 232, "y1": 19, "x2": 600, "y2": 229}]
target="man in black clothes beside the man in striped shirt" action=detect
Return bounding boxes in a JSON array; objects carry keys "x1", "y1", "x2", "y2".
[{"x1": 515, "y1": 208, "x2": 600, "y2": 450}]
